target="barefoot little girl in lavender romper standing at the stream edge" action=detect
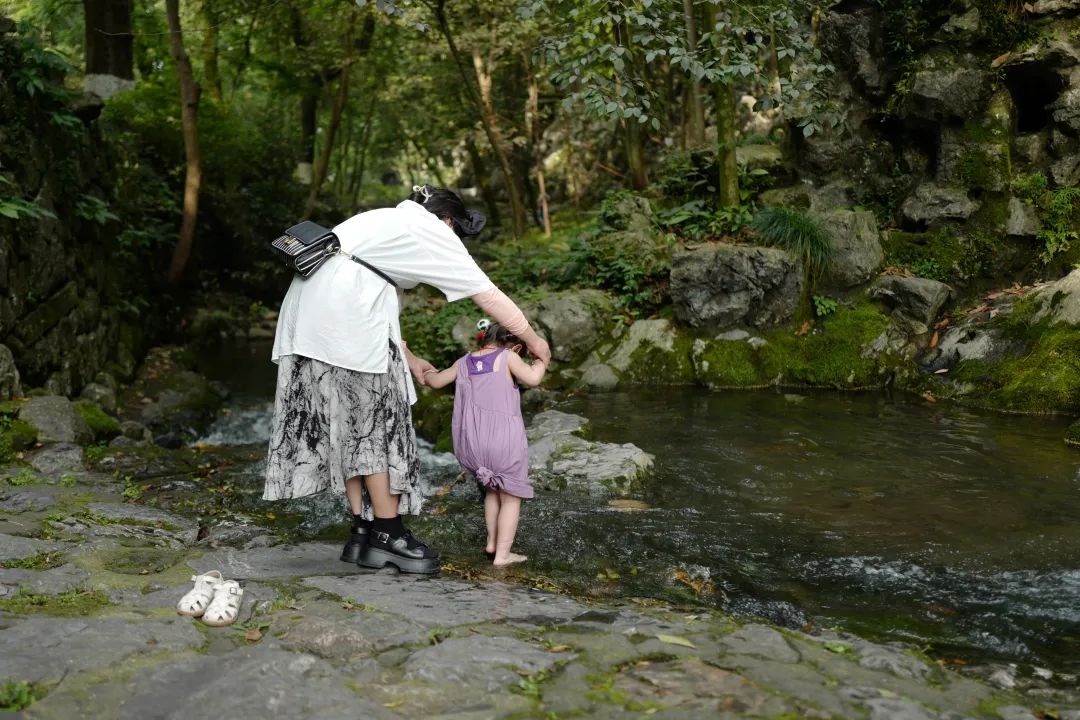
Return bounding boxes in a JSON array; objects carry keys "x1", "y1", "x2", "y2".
[{"x1": 424, "y1": 320, "x2": 545, "y2": 567}]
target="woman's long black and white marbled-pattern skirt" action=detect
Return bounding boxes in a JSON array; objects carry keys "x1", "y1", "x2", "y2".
[{"x1": 262, "y1": 341, "x2": 423, "y2": 518}]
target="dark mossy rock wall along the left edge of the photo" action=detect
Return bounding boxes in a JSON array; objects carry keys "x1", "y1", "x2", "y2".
[{"x1": 0, "y1": 17, "x2": 145, "y2": 396}]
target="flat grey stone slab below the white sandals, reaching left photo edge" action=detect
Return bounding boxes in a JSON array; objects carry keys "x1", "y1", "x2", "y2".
[{"x1": 0, "y1": 617, "x2": 203, "y2": 686}]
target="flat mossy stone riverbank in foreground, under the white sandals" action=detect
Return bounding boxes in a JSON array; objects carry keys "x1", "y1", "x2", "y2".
[{"x1": 0, "y1": 451, "x2": 1080, "y2": 720}]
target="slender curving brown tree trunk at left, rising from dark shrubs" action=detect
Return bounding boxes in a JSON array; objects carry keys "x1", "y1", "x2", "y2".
[{"x1": 165, "y1": 0, "x2": 202, "y2": 284}]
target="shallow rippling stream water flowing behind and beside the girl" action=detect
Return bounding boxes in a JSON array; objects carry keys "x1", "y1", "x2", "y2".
[{"x1": 192, "y1": 348, "x2": 1080, "y2": 673}]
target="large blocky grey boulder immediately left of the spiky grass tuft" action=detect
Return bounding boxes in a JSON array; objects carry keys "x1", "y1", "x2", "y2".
[{"x1": 671, "y1": 243, "x2": 804, "y2": 327}]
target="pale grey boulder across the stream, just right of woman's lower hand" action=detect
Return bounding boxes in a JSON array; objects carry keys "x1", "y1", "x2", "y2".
[{"x1": 526, "y1": 289, "x2": 613, "y2": 363}]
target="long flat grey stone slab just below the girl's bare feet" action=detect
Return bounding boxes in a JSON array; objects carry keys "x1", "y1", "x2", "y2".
[{"x1": 303, "y1": 573, "x2": 588, "y2": 627}]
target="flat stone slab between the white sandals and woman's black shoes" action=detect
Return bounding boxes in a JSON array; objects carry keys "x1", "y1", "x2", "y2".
[{"x1": 188, "y1": 543, "x2": 370, "y2": 580}]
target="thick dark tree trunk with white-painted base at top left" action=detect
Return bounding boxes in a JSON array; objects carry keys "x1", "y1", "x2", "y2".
[{"x1": 82, "y1": 0, "x2": 135, "y2": 98}]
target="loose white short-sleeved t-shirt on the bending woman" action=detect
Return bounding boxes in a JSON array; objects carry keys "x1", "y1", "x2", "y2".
[{"x1": 272, "y1": 200, "x2": 495, "y2": 403}]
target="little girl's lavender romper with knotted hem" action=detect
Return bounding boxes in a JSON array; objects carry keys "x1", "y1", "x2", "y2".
[{"x1": 454, "y1": 349, "x2": 532, "y2": 498}]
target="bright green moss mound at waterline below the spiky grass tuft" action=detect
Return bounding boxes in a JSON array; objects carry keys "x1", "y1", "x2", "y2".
[{"x1": 758, "y1": 302, "x2": 889, "y2": 388}]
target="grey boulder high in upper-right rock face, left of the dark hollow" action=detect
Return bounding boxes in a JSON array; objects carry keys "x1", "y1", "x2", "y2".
[{"x1": 904, "y1": 51, "x2": 990, "y2": 122}]
